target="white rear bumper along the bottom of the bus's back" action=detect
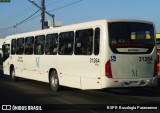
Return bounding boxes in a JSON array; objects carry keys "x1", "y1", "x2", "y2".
[{"x1": 102, "y1": 76, "x2": 158, "y2": 88}]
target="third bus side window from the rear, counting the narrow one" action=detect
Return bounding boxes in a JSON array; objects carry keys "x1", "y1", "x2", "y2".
[{"x1": 59, "y1": 31, "x2": 74, "y2": 55}]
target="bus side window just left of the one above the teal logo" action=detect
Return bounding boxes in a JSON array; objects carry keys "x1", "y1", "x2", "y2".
[{"x1": 25, "y1": 37, "x2": 34, "y2": 55}]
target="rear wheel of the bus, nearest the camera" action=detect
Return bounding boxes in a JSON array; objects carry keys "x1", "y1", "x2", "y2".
[{"x1": 49, "y1": 71, "x2": 60, "y2": 91}]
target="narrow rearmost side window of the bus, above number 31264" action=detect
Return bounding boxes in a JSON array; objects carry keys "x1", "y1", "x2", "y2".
[{"x1": 94, "y1": 28, "x2": 100, "y2": 55}]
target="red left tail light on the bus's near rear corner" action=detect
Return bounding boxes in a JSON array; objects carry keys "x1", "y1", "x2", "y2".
[{"x1": 105, "y1": 60, "x2": 112, "y2": 78}]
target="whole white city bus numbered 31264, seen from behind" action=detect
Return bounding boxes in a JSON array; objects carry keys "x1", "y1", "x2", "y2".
[{"x1": 3, "y1": 20, "x2": 158, "y2": 91}]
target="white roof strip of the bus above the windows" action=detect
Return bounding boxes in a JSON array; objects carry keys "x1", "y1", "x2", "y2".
[{"x1": 5, "y1": 19, "x2": 153, "y2": 39}]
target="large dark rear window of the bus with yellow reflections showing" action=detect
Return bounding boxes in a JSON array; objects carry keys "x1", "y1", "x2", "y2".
[{"x1": 108, "y1": 22, "x2": 155, "y2": 47}]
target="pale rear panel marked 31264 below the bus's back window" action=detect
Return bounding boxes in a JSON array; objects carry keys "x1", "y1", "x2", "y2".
[{"x1": 111, "y1": 54, "x2": 155, "y2": 79}]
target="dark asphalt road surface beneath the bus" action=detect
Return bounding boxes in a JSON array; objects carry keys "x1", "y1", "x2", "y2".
[{"x1": 0, "y1": 70, "x2": 160, "y2": 113}]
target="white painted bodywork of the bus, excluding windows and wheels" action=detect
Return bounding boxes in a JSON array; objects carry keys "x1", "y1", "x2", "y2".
[{"x1": 3, "y1": 20, "x2": 157, "y2": 89}]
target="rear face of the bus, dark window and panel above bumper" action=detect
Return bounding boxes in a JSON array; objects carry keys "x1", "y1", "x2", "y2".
[{"x1": 108, "y1": 21, "x2": 157, "y2": 82}]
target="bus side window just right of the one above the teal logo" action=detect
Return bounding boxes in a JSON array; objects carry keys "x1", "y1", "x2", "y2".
[{"x1": 45, "y1": 33, "x2": 58, "y2": 55}]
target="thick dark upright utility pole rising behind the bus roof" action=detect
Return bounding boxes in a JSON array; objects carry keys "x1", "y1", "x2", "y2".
[{"x1": 41, "y1": 0, "x2": 46, "y2": 29}]
